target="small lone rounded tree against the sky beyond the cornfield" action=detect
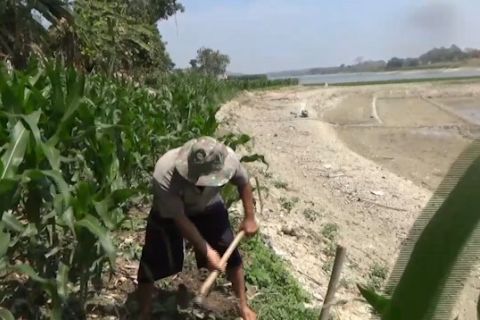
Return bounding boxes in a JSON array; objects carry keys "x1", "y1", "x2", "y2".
[{"x1": 190, "y1": 47, "x2": 230, "y2": 76}]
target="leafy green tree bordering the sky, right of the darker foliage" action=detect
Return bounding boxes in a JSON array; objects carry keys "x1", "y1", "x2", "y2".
[{"x1": 75, "y1": 0, "x2": 173, "y2": 78}]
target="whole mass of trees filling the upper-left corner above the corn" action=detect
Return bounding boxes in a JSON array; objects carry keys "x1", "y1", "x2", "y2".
[{"x1": 0, "y1": 0, "x2": 178, "y2": 78}]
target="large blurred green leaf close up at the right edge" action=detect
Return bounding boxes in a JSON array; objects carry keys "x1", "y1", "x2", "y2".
[{"x1": 382, "y1": 140, "x2": 480, "y2": 320}]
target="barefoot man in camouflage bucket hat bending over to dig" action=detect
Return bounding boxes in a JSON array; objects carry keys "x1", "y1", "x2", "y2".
[{"x1": 138, "y1": 137, "x2": 258, "y2": 320}]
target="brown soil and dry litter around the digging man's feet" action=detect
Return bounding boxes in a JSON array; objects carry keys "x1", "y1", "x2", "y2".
[{"x1": 87, "y1": 207, "x2": 238, "y2": 320}]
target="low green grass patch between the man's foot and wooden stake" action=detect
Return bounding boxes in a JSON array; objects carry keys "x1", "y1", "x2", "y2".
[{"x1": 241, "y1": 236, "x2": 319, "y2": 320}]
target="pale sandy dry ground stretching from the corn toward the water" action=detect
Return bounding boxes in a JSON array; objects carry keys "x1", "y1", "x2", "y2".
[{"x1": 219, "y1": 84, "x2": 480, "y2": 320}]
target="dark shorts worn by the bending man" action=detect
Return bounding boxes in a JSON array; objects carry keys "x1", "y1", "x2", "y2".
[{"x1": 137, "y1": 203, "x2": 242, "y2": 283}]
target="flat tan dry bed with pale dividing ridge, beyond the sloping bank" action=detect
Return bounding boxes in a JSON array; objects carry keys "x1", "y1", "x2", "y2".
[{"x1": 324, "y1": 96, "x2": 480, "y2": 190}]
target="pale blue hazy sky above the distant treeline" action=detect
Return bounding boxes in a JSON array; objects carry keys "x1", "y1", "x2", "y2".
[{"x1": 158, "y1": 0, "x2": 480, "y2": 73}]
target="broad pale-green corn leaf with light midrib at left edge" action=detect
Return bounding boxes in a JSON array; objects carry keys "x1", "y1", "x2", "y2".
[{"x1": 0, "y1": 121, "x2": 29, "y2": 179}]
